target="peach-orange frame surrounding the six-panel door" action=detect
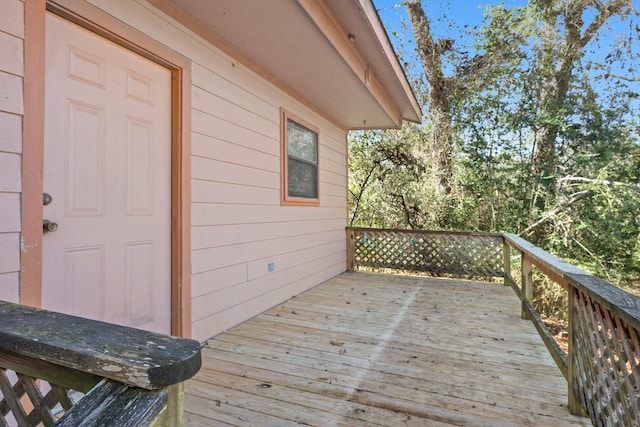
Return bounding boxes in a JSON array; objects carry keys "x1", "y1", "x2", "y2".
[{"x1": 20, "y1": 0, "x2": 191, "y2": 337}]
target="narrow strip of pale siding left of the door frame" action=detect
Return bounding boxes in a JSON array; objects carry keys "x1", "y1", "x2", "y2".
[{"x1": 0, "y1": 0, "x2": 24, "y2": 302}]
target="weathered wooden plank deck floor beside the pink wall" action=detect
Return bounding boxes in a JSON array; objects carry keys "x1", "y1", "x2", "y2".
[{"x1": 185, "y1": 273, "x2": 591, "y2": 427}]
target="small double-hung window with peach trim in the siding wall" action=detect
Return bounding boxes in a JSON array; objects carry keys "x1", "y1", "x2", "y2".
[{"x1": 282, "y1": 112, "x2": 320, "y2": 206}]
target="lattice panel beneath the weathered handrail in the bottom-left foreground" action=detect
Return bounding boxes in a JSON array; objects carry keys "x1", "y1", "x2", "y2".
[{"x1": 0, "y1": 368, "x2": 73, "y2": 426}]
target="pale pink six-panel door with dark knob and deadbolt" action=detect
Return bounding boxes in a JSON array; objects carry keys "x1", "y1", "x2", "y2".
[{"x1": 42, "y1": 14, "x2": 171, "y2": 333}]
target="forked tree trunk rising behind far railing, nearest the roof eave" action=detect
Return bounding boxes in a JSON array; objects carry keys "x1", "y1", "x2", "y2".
[{"x1": 406, "y1": 0, "x2": 524, "y2": 228}]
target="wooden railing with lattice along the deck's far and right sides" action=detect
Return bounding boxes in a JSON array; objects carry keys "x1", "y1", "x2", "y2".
[{"x1": 347, "y1": 228, "x2": 640, "y2": 426}]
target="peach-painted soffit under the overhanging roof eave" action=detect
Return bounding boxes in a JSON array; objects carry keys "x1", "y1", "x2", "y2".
[{"x1": 164, "y1": 0, "x2": 420, "y2": 129}]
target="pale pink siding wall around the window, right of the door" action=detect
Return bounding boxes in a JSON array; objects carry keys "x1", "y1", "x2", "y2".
[{"x1": 95, "y1": 0, "x2": 347, "y2": 341}]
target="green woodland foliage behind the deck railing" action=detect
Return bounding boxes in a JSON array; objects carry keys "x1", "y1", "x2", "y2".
[{"x1": 349, "y1": 0, "x2": 640, "y2": 293}]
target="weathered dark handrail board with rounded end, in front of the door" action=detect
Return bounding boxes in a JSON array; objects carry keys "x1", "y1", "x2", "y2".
[{"x1": 0, "y1": 301, "x2": 201, "y2": 390}]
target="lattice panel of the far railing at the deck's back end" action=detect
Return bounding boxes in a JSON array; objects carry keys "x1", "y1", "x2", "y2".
[{"x1": 353, "y1": 229, "x2": 504, "y2": 277}]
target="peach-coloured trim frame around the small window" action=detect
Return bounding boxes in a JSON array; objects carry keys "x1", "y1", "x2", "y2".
[{"x1": 280, "y1": 108, "x2": 320, "y2": 206}]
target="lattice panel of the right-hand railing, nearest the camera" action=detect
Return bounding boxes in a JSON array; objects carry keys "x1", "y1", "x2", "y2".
[{"x1": 572, "y1": 288, "x2": 640, "y2": 426}]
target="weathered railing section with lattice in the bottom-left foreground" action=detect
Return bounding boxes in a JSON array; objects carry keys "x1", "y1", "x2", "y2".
[{"x1": 0, "y1": 301, "x2": 201, "y2": 427}]
